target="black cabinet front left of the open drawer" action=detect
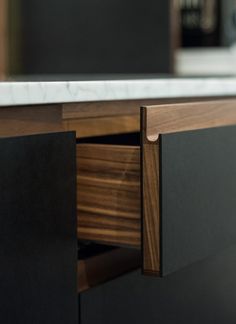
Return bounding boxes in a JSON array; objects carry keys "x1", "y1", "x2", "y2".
[{"x1": 0, "y1": 133, "x2": 78, "y2": 324}]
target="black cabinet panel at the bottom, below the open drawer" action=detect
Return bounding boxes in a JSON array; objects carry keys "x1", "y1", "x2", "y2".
[{"x1": 81, "y1": 247, "x2": 236, "y2": 324}]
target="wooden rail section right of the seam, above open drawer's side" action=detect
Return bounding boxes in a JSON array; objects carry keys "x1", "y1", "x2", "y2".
[{"x1": 62, "y1": 98, "x2": 221, "y2": 138}]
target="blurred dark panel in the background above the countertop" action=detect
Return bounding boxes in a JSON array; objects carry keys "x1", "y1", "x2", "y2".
[{"x1": 16, "y1": 0, "x2": 171, "y2": 74}]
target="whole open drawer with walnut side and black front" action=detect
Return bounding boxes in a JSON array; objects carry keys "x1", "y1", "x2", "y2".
[{"x1": 77, "y1": 100, "x2": 236, "y2": 276}]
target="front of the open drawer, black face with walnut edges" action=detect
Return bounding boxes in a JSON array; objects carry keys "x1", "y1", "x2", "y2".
[{"x1": 142, "y1": 100, "x2": 236, "y2": 276}]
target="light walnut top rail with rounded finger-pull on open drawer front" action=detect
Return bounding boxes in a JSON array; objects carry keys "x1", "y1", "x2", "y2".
[{"x1": 143, "y1": 99, "x2": 236, "y2": 141}]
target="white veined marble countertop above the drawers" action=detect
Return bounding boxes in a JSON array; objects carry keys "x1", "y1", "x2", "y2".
[{"x1": 0, "y1": 77, "x2": 236, "y2": 106}]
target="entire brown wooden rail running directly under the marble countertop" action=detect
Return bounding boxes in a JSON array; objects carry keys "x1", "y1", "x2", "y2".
[{"x1": 0, "y1": 97, "x2": 229, "y2": 138}]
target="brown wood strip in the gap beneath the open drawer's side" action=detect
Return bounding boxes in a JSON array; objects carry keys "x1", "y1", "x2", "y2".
[{"x1": 78, "y1": 248, "x2": 141, "y2": 293}]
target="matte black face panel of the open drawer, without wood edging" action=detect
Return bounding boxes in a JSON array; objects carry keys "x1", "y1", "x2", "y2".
[{"x1": 160, "y1": 126, "x2": 236, "y2": 275}]
